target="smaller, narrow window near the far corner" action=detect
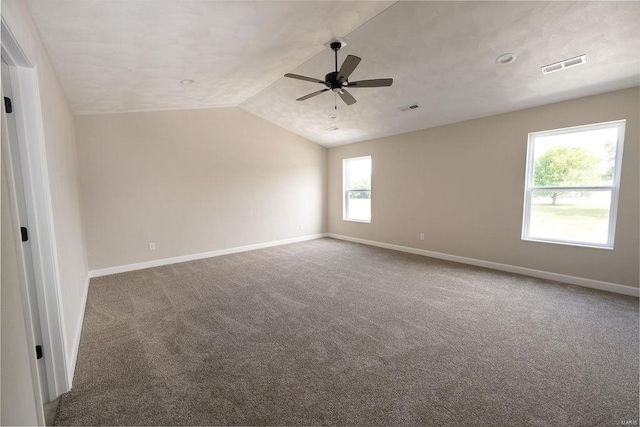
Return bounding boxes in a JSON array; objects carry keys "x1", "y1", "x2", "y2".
[{"x1": 342, "y1": 156, "x2": 371, "y2": 222}]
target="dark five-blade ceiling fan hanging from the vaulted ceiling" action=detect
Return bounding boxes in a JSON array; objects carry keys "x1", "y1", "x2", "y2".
[{"x1": 284, "y1": 42, "x2": 393, "y2": 105}]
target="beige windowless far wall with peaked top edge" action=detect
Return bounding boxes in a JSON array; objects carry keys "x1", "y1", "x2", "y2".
[{"x1": 76, "y1": 108, "x2": 326, "y2": 270}]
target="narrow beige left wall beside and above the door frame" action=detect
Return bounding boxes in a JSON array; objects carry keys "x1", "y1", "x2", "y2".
[{"x1": 2, "y1": 0, "x2": 88, "y2": 400}]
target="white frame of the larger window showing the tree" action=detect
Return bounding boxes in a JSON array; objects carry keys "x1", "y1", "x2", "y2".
[{"x1": 522, "y1": 119, "x2": 626, "y2": 250}]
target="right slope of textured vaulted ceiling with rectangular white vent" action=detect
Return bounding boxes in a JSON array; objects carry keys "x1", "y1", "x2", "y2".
[{"x1": 241, "y1": 2, "x2": 640, "y2": 147}]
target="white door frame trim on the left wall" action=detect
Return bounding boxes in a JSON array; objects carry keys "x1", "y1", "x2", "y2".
[{"x1": 1, "y1": 17, "x2": 72, "y2": 399}]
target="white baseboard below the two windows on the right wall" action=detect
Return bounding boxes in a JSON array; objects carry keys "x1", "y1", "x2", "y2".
[{"x1": 327, "y1": 233, "x2": 640, "y2": 298}]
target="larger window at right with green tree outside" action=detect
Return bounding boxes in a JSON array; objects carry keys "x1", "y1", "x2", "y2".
[{"x1": 522, "y1": 120, "x2": 625, "y2": 249}]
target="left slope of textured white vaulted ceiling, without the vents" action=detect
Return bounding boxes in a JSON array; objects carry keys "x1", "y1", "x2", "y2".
[{"x1": 29, "y1": 0, "x2": 393, "y2": 114}]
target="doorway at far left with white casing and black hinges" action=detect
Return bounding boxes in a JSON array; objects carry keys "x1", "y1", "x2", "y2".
[{"x1": 1, "y1": 17, "x2": 71, "y2": 423}]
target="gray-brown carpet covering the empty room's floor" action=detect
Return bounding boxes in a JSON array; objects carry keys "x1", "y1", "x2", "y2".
[{"x1": 56, "y1": 239, "x2": 639, "y2": 426}]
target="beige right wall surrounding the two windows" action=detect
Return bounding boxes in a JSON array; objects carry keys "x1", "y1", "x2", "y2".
[{"x1": 328, "y1": 88, "x2": 640, "y2": 287}]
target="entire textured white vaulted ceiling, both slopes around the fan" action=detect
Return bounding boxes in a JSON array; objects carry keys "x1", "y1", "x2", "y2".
[{"x1": 29, "y1": 0, "x2": 640, "y2": 147}]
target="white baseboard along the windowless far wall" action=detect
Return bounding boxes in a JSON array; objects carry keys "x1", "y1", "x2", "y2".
[{"x1": 89, "y1": 233, "x2": 327, "y2": 278}]
